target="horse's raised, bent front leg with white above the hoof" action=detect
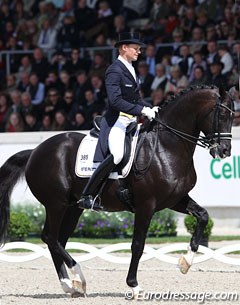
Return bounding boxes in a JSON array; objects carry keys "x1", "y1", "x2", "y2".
[{"x1": 171, "y1": 195, "x2": 208, "y2": 273}]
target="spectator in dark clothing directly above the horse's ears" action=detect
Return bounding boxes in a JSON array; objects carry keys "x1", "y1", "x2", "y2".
[{"x1": 206, "y1": 61, "x2": 227, "y2": 88}]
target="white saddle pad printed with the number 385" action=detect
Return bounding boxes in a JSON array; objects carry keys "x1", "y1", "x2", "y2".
[{"x1": 75, "y1": 124, "x2": 141, "y2": 179}]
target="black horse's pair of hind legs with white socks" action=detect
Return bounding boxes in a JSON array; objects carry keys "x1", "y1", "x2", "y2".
[{"x1": 42, "y1": 203, "x2": 86, "y2": 297}]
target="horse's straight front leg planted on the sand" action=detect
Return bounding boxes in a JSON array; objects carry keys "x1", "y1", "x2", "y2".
[{"x1": 126, "y1": 204, "x2": 153, "y2": 298}]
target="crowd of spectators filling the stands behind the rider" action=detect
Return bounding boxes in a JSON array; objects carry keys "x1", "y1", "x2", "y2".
[{"x1": 0, "y1": 0, "x2": 240, "y2": 132}]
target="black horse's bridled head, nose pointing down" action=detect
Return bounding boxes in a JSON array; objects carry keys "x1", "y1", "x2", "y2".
[{"x1": 205, "y1": 85, "x2": 234, "y2": 158}]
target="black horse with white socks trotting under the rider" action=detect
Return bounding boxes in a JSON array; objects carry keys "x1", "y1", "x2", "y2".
[{"x1": 0, "y1": 86, "x2": 234, "y2": 296}]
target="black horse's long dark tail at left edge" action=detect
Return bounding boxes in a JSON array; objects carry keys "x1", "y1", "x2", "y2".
[{"x1": 0, "y1": 149, "x2": 32, "y2": 244}]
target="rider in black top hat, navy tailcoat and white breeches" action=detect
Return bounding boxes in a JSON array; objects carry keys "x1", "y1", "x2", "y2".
[{"x1": 78, "y1": 32, "x2": 158, "y2": 210}]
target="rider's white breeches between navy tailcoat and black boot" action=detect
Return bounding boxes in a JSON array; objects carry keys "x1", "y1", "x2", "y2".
[{"x1": 108, "y1": 116, "x2": 136, "y2": 165}]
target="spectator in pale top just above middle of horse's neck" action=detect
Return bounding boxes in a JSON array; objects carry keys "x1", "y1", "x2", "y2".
[{"x1": 164, "y1": 65, "x2": 188, "y2": 94}]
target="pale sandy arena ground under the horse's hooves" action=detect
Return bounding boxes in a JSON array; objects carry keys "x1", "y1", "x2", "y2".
[{"x1": 0, "y1": 243, "x2": 240, "y2": 305}]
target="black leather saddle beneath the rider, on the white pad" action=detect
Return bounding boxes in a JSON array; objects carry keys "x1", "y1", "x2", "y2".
[{"x1": 90, "y1": 115, "x2": 138, "y2": 169}]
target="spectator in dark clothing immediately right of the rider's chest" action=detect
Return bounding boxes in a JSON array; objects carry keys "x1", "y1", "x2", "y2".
[{"x1": 137, "y1": 60, "x2": 154, "y2": 98}]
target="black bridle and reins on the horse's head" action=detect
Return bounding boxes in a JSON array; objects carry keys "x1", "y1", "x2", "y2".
[{"x1": 154, "y1": 93, "x2": 235, "y2": 149}]
